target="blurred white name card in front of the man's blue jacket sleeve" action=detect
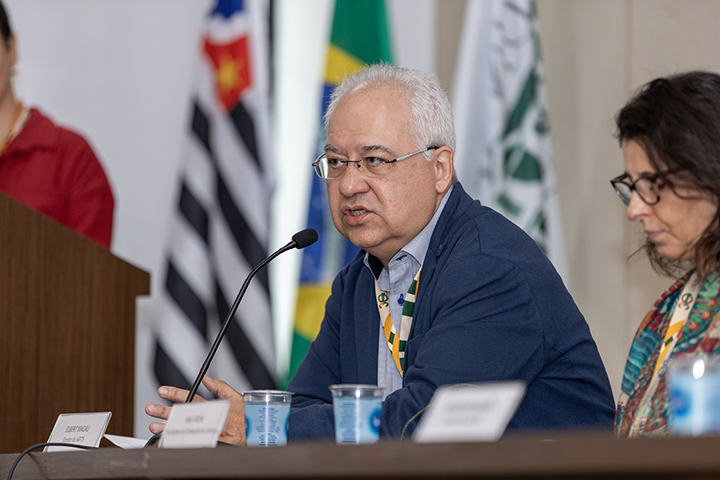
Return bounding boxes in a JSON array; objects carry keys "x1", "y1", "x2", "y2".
[{"x1": 413, "y1": 381, "x2": 525, "y2": 443}]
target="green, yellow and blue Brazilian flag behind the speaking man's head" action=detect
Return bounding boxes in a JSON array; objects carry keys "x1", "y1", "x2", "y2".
[{"x1": 288, "y1": 0, "x2": 392, "y2": 382}]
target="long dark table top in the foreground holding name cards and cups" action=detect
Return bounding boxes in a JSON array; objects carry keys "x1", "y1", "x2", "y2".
[{"x1": 0, "y1": 435, "x2": 720, "y2": 480}]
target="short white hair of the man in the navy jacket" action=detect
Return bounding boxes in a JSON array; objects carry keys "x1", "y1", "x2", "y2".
[{"x1": 324, "y1": 63, "x2": 455, "y2": 160}]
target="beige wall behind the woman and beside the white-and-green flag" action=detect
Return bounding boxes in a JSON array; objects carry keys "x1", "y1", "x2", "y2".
[{"x1": 437, "y1": 0, "x2": 720, "y2": 397}]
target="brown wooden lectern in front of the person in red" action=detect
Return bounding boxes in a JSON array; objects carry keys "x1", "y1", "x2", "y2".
[{"x1": 0, "y1": 193, "x2": 150, "y2": 453}]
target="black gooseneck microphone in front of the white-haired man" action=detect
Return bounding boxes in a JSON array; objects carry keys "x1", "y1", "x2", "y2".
[{"x1": 145, "y1": 228, "x2": 318, "y2": 447}]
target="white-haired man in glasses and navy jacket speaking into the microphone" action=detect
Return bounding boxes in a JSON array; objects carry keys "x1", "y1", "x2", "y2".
[{"x1": 146, "y1": 65, "x2": 614, "y2": 444}]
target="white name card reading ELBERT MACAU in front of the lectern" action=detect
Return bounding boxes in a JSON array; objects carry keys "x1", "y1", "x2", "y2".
[{"x1": 43, "y1": 412, "x2": 112, "y2": 452}]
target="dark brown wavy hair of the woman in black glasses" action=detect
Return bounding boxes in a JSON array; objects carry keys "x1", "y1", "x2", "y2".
[{"x1": 615, "y1": 71, "x2": 720, "y2": 279}]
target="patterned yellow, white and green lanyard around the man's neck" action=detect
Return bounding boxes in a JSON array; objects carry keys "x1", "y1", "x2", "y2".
[{"x1": 375, "y1": 265, "x2": 422, "y2": 376}]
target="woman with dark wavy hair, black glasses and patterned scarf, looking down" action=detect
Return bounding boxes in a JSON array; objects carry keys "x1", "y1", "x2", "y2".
[{"x1": 611, "y1": 71, "x2": 720, "y2": 436}]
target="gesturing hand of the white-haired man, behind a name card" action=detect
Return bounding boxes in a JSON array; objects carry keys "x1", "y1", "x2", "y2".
[{"x1": 145, "y1": 376, "x2": 245, "y2": 446}]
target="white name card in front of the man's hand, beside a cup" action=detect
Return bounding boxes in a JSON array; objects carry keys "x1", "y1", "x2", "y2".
[{"x1": 159, "y1": 400, "x2": 230, "y2": 448}]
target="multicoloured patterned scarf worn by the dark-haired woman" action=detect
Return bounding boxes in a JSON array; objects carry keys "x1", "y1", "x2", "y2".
[{"x1": 615, "y1": 270, "x2": 720, "y2": 436}]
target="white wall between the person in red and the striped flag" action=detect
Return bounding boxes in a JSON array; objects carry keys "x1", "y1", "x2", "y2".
[{"x1": 5, "y1": 0, "x2": 207, "y2": 271}]
